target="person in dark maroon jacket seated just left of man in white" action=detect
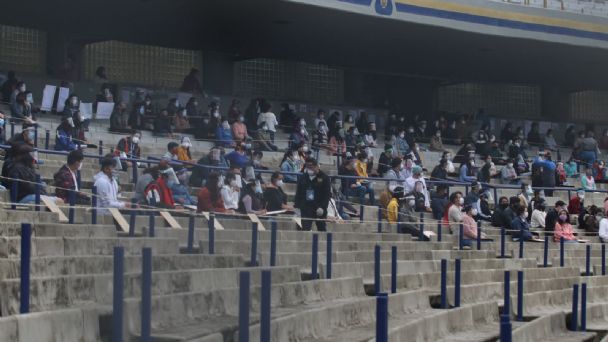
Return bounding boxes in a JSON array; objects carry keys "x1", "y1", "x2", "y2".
[{"x1": 53, "y1": 150, "x2": 91, "y2": 205}]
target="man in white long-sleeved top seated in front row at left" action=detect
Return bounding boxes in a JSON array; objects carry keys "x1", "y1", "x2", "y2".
[{"x1": 94, "y1": 158, "x2": 129, "y2": 215}]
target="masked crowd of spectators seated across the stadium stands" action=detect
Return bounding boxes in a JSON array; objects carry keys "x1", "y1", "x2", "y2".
[{"x1": 0, "y1": 70, "x2": 608, "y2": 244}]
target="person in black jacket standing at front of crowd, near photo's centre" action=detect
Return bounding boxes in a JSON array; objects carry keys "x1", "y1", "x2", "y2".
[{"x1": 295, "y1": 158, "x2": 331, "y2": 231}]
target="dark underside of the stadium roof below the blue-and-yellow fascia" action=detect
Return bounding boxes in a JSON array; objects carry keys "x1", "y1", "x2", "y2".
[{"x1": 0, "y1": 0, "x2": 608, "y2": 89}]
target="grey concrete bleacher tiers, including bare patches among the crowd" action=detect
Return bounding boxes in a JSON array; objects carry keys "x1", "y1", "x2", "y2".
[{"x1": 0, "y1": 105, "x2": 608, "y2": 341}]
